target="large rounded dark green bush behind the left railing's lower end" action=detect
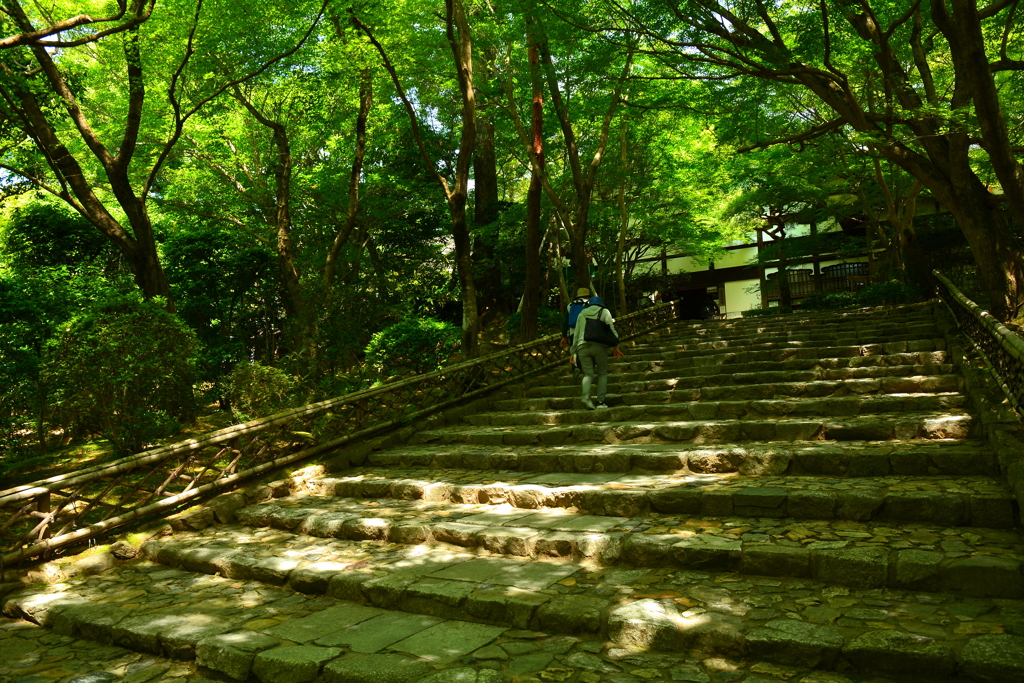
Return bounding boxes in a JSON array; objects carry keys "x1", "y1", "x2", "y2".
[{"x1": 43, "y1": 297, "x2": 199, "y2": 454}]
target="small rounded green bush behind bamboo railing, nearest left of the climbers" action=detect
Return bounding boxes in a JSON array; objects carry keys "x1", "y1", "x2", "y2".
[{"x1": 367, "y1": 317, "x2": 462, "y2": 377}]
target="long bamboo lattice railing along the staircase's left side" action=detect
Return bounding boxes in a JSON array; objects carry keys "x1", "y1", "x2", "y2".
[{"x1": 0, "y1": 302, "x2": 679, "y2": 569}]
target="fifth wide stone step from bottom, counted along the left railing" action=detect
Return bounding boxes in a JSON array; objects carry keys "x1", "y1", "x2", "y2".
[{"x1": 364, "y1": 439, "x2": 998, "y2": 477}]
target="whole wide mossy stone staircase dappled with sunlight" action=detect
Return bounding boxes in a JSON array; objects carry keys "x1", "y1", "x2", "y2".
[{"x1": 0, "y1": 304, "x2": 1024, "y2": 683}]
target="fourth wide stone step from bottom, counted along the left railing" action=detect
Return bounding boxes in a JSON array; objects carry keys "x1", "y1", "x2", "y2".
[{"x1": 276, "y1": 471, "x2": 1016, "y2": 528}]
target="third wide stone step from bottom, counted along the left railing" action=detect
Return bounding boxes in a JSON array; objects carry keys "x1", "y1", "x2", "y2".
[{"x1": 169, "y1": 497, "x2": 1024, "y2": 599}]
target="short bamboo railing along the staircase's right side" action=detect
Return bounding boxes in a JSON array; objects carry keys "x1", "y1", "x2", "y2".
[{"x1": 932, "y1": 270, "x2": 1024, "y2": 415}]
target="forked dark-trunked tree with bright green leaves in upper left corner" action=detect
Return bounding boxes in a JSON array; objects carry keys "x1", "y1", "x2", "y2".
[{"x1": 0, "y1": 0, "x2": 328, "y2": 309}]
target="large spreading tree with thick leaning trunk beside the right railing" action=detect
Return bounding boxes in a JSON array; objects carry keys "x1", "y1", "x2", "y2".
[{"x1": 605, "y1": 0, "x2": 1024, "y2": 319}]
